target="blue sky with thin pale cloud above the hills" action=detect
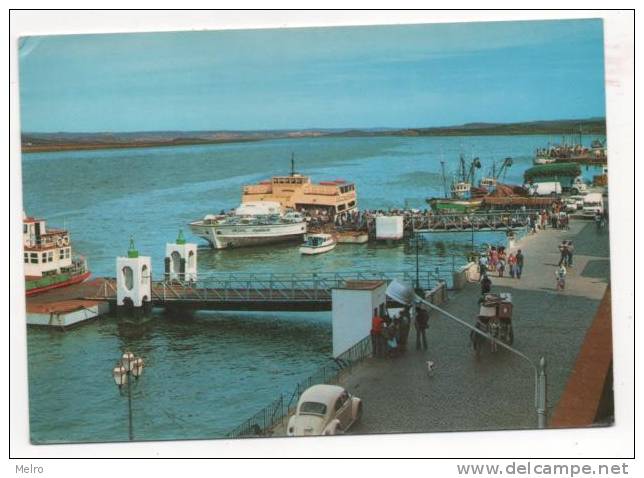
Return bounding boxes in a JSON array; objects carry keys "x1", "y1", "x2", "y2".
[{"x1": 19, "y1": 19, "x2": 605, "y2": 132}]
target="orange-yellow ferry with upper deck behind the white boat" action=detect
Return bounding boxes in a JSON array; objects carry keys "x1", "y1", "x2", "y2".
[{"x1": 242, "y1": 157, "x2": 358, "y2": 218}]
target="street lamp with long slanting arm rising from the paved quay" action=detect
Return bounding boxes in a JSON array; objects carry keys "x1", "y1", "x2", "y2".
[{"x1": 387, "y1": 279, "x2": 546, "y2": 428}]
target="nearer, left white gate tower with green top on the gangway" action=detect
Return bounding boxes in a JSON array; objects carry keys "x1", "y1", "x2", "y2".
[{"x1": 116, "y1": 238, "x2": 152, "y2": 312}]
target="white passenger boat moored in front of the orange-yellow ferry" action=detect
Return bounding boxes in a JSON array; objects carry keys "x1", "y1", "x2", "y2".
[{"x1": 190, "y1": 201, "x2": 306, "y2": 249}]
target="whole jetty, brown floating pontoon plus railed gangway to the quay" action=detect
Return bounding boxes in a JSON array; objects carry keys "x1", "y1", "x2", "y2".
[{"x1": 27, "y1": 263, "x2": 454, "y2": 327}]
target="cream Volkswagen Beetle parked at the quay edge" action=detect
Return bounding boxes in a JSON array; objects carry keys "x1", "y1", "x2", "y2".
[{"x1": 286, "y1": 385, "x2": 362, "y2": 436}]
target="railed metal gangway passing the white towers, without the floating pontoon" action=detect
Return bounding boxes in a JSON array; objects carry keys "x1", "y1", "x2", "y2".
[{"x1": 86, "y1": 270, "x2": 453, "y2": 311}]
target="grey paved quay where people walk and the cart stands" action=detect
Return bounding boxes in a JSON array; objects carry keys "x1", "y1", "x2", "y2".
[{"x1": 341, "y1": 220, "x2": 610, "y2": 434}]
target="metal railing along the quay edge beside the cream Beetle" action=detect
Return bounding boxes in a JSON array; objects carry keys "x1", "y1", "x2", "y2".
[{"x1": 225, "y1": 336, "x2": 372, "y2": 438}]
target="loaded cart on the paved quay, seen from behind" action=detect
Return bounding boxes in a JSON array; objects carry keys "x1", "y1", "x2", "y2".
[{"x1": 470, "y1": 293, "x2": 514, "y2": 355}]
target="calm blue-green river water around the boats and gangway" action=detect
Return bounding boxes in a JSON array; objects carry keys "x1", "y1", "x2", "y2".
[{"x1": 22, "y1": 136, "x2": 597, "y2": 442}]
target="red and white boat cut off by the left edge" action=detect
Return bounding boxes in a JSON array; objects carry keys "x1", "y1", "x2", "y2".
[{"x1": 22, "y1": 213, "x2": 91, "y2": 296}]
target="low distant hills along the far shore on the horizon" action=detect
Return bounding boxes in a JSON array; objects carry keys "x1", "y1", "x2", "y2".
[{"x1": 21, "y1": 118, "x2": 606, "y2": 152}]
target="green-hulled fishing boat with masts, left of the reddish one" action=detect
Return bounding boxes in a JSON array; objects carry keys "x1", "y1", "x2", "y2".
[{"x1": 426, "y1": 155, "x2": 482, "y2": 214}]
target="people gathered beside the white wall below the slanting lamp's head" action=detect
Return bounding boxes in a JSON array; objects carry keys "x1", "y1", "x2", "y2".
[{"x1": 371, "y1": 306, "x2": 429, "y2": 358}]
